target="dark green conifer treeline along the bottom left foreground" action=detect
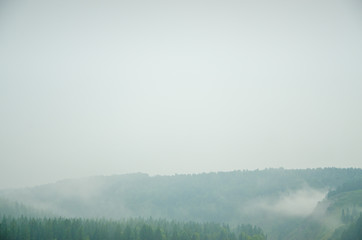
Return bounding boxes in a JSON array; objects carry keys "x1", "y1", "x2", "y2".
[{"x1": 0, "y1": 216, "x2": 267, "y2": 240}]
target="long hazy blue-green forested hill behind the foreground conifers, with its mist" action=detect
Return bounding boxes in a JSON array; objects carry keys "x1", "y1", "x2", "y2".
[{"x1": 0, "y1": 168, "x2": 362, "y2": 239}]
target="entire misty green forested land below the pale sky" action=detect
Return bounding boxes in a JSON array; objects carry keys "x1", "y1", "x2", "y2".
[{"x1": 0, "y1": 168, "x2": 362, "y2": 240}]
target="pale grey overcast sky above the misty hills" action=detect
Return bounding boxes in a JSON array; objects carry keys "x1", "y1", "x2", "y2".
[{"x1": 0, "y1": 0, "x2": 362, "y2": 189}]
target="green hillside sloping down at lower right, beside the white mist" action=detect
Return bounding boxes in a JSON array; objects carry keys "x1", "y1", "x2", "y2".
[{"x1": 279, "y1": 180, "x2": 362, "y2": 240}]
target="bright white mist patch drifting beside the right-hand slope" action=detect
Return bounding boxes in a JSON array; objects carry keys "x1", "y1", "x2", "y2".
[{"x1": 256, "y1": 188, "x2": 327, "y2": 217}]
